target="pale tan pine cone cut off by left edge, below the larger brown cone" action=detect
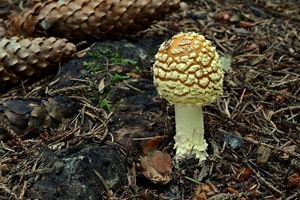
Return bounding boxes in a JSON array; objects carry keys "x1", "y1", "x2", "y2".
[{"x1": 0, "y1": 37, "x2": 76, "y2": 83}]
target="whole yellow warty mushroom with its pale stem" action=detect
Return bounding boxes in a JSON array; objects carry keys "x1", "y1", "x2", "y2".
[{"x1": 153, "y1": 32, "x2": 224, "y2": 161}]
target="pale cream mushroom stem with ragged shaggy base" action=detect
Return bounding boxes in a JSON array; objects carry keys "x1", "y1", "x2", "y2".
[{"x1": 174, "y1": 105, "x2": 207, "y2": 161}]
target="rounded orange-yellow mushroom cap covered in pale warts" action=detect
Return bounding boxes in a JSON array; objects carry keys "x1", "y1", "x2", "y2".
[{"x1": 153, "y1": 32, "x2": 224, "y2": 105}]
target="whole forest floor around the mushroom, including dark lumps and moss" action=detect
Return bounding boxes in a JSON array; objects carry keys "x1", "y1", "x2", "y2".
[{"x1": 0, "y1": 0, "x2": 300, "y2": 200}]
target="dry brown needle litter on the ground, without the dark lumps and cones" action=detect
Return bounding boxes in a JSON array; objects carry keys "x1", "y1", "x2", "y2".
[{"x1": 0, "y1": 0, "x2": 300, "y2": 200}]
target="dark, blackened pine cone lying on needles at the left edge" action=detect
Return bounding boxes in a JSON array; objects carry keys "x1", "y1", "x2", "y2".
[{"x1": 0, "y1": 96, "x2": 79, "y2": 138}]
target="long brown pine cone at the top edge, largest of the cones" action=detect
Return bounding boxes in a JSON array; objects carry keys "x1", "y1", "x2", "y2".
[{"x1": 10, "y1": 0, "x2": 180, "y2": 40}]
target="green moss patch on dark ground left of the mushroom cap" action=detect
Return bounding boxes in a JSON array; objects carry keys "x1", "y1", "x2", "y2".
[{"x1": 82, "y1": 41, "x2": 150, "y2": 112}]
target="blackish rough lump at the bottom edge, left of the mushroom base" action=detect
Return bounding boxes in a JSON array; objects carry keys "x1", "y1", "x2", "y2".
[{"x1": 26, "y1": 143, "x2": 127, "y2": 200}]
